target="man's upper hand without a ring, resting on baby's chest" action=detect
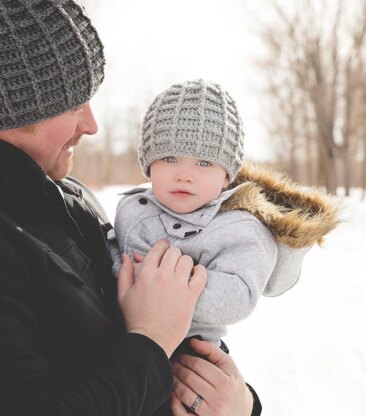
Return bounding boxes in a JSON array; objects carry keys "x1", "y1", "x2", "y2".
[{"x1": 117, "y1": 240, "x2": 207, "y2": 357}]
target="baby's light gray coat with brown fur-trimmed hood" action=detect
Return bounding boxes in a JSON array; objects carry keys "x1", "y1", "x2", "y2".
[{"x1": 108, "y1": 166, "x2": 337, "y2": 342}]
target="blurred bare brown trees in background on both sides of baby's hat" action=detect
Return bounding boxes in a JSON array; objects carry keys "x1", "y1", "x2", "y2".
[{"x1": 72, "y1": 0, "x2": 366, "y2": 194}]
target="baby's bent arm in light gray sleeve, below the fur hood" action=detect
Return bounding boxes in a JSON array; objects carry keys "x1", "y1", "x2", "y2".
[{"x1": 193, "y1": 213, "x2": 277, "y2": 325}]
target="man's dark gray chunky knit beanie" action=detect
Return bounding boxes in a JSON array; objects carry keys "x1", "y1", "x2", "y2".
[{"x1": 0, "y1": 0, "x2": 104, "y2": 130}]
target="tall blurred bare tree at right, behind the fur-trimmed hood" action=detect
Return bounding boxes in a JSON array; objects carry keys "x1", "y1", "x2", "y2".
[{"x1": 261, "y1": 0, "x2": 366, "y2": 193}]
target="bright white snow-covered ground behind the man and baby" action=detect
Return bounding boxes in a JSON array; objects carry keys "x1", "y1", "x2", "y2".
[{"x1": 97, "y1": 187, "x2": 366, "y2": 416}]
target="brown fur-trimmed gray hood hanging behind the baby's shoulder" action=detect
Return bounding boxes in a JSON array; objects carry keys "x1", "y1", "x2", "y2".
[{"x1": 221, "y1": 164, "x2": 339, "y2": 296}]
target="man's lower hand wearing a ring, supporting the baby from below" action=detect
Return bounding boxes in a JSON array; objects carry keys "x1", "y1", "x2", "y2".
[{"x1": 171, "y1": 339, "x2": 253, "y2": 416}]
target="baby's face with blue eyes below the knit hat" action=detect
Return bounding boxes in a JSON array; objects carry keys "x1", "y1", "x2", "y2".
[{"x1": 150, "y1": 156, "x2": 229, "y2": 214}]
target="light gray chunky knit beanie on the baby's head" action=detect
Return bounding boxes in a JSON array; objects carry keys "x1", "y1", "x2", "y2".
[{"x1": 139, "y1": 80, "x2": 244, "y2": 181}]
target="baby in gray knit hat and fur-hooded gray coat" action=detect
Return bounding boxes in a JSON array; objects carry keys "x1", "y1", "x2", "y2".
[{"x1": 109, "y1": 80, "x2": 337, "y2": 349}]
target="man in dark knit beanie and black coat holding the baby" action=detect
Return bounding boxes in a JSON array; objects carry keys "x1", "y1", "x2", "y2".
[{"x1": 0, "y1": 0, "x2": 260, "y2": 416}]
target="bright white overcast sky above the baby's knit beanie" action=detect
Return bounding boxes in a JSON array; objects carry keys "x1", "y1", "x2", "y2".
[{"x1": 84, "y1": 0, "x2": 348, "y2": 159}]
